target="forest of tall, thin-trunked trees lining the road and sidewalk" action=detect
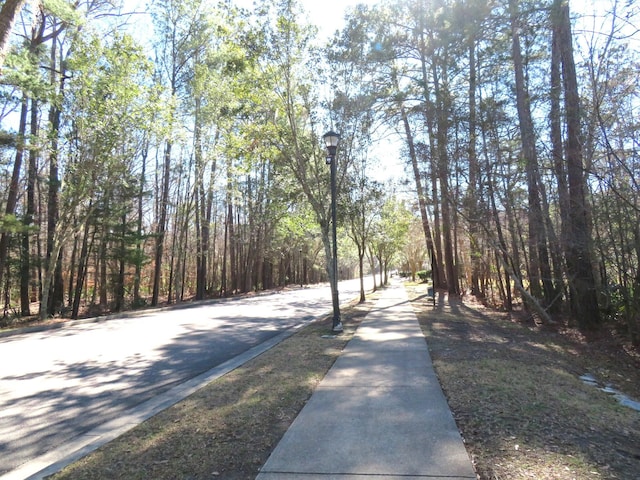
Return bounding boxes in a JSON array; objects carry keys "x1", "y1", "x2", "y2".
[{"x1": 0, "y1": 0, "x2": 640, "y2": 344}]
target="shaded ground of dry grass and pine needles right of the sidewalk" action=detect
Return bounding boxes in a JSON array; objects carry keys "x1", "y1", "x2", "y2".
[{"x1": 408, "y1": 285, "x2": 640, "y2": 480}]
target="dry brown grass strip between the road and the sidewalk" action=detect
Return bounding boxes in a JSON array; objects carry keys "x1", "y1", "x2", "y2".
[{"x1": 51, "y1": 301, "x2": 380, "y2": 480}]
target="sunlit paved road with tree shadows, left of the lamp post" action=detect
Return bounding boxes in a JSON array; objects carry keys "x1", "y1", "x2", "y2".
[{"x1": 0, "y1": 281, "x2": 370, "y2": 476}]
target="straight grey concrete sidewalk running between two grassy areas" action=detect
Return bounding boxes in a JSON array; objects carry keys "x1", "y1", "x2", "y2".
[{"x1": 257, "y1": 282, "x2": 476, "y2": 480}]
